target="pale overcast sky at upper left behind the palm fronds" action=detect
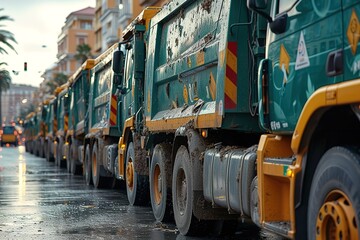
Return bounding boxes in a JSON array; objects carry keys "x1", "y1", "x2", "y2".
[{"x1": 0, "y1": 0, "x2": 96, "y2": 87}]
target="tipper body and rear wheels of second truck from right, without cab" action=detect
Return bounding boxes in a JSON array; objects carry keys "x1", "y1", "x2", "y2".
[{"x1": 82, "y1": 43, "x2": 125, "y2": 188}]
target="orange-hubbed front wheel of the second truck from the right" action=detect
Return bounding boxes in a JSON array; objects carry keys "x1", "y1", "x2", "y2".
[{"x1": 125, "y1": 142, "x2": 149, "y2": 206}]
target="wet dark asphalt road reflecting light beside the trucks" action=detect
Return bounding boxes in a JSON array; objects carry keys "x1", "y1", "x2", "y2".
[{"x1": 0, "y1": 146, "x2": 282, "y2": 240}]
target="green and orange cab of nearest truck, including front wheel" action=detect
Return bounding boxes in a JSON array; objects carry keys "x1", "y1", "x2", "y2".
[{"x1": 247, "y1": 0, "x2": 360, "y2": 239}]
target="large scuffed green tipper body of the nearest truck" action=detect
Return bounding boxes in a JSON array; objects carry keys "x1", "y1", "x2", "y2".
[{"x1": 145, "y1": 0, "x2": 266, "y2": 132}]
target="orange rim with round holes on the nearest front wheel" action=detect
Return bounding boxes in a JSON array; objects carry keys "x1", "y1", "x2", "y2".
[{"x1": 316, "y1": 190, "x2": 359, "y2": 240}]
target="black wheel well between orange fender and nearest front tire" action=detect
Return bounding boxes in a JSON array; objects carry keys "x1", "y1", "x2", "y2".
[{"x1": 292, "y1": 104, "x2": 360, "y2": 239}]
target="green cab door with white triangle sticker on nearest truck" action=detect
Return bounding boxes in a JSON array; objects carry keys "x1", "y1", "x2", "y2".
[{"x1": 267, "y1": 0, "x2": 344, "y2": 133}]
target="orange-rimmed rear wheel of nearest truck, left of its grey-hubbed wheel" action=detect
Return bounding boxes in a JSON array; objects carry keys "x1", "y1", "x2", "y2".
[{"x1": 149, "y1": 144, "x2": 173, "y2": 222}]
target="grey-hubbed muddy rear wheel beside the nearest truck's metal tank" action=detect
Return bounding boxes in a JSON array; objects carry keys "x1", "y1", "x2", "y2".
[{"x1": 172, "y1": 146, "x2": 200, "y2": 235}]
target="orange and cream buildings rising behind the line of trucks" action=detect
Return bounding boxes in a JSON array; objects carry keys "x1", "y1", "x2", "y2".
[{"x1": 39, "y1": 0, "x2": 168, "y2": 99}]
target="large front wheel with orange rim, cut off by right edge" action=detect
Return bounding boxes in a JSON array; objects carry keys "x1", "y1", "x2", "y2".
[{"x1": 307, "y1": 147, "x2": 360, "y2": 240}]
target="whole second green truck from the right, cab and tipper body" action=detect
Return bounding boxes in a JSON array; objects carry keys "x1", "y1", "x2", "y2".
[{"x1": 84, "y1": 7, "x2": 159, "y2": 205}]
